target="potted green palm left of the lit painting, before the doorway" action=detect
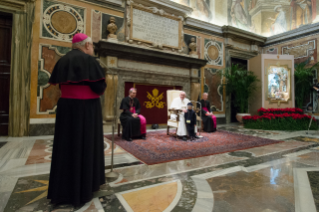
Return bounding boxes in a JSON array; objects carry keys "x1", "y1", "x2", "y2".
[{"x1": 221, "y1": 65, "x2": 259, "y2": 123}]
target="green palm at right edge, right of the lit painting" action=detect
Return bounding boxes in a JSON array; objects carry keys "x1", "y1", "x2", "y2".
[{"x1": 295, "y1": 58, "x2": 319, "y2": 109}]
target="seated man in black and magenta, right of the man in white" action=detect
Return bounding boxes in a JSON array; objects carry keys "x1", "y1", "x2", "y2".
[{"x1": 197, "y1": 93, "x2": 217, "y2": 132}]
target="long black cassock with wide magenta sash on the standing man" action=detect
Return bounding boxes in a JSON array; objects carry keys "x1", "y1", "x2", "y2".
[{"x1": 48, "y1": 50, "x2": 106, "y2": 206}]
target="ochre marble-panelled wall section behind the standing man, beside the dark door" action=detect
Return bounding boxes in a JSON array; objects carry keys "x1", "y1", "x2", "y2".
[{"x1": 28, "y1": 0, "x2": 124, "y2": 135}]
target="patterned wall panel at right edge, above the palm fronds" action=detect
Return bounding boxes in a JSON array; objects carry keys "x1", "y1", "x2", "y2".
[{"x1": 281, "y1": 39, "x2": 317, "y2": 65}]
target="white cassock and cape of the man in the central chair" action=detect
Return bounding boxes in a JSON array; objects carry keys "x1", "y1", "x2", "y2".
[{"x1": 170, "y1": 97, "x2": 197, "y2": 136}]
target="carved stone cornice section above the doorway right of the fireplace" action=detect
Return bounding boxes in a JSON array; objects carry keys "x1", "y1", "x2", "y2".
[{"x1": 222, "y1": 26, "x2": 267, "y2": 46}]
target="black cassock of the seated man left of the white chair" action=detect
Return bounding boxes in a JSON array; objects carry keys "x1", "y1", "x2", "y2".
[{"x1": 120, "y1": 97, "x2": 143, "y2": 140}]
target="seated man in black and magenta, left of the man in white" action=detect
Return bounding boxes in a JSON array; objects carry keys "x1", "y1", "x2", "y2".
[{"x1": 120, "y1": 88, "x2": 146, "y2": 141}]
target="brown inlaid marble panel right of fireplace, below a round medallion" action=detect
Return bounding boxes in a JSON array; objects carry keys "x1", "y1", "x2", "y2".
[{"x1": 204, "y1": 68, "x2": 224, "y2": 112}]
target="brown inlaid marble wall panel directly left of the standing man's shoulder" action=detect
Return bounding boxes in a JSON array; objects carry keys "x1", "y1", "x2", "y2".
[{"x1": 37, "y1": 44, "x2": 71, "y2": 114}]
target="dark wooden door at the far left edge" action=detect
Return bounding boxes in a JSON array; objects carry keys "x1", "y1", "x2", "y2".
[{"x1": 0, "y1": 12, "x2": 12, "y2": 136}]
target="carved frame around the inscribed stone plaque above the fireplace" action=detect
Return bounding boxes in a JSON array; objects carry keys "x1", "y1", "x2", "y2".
[{"x1": 129, "y1": 4, "x2": 183, "y2": 49}]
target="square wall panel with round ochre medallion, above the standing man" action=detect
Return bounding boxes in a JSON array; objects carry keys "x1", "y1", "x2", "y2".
[{"x1": 41, "y1": 0, "x2": 85, "y2": 42}]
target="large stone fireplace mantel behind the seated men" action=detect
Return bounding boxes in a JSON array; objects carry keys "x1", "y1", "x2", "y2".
[{"x1": 94, "y1": 40, "x2": 207, "y2": 123}]
